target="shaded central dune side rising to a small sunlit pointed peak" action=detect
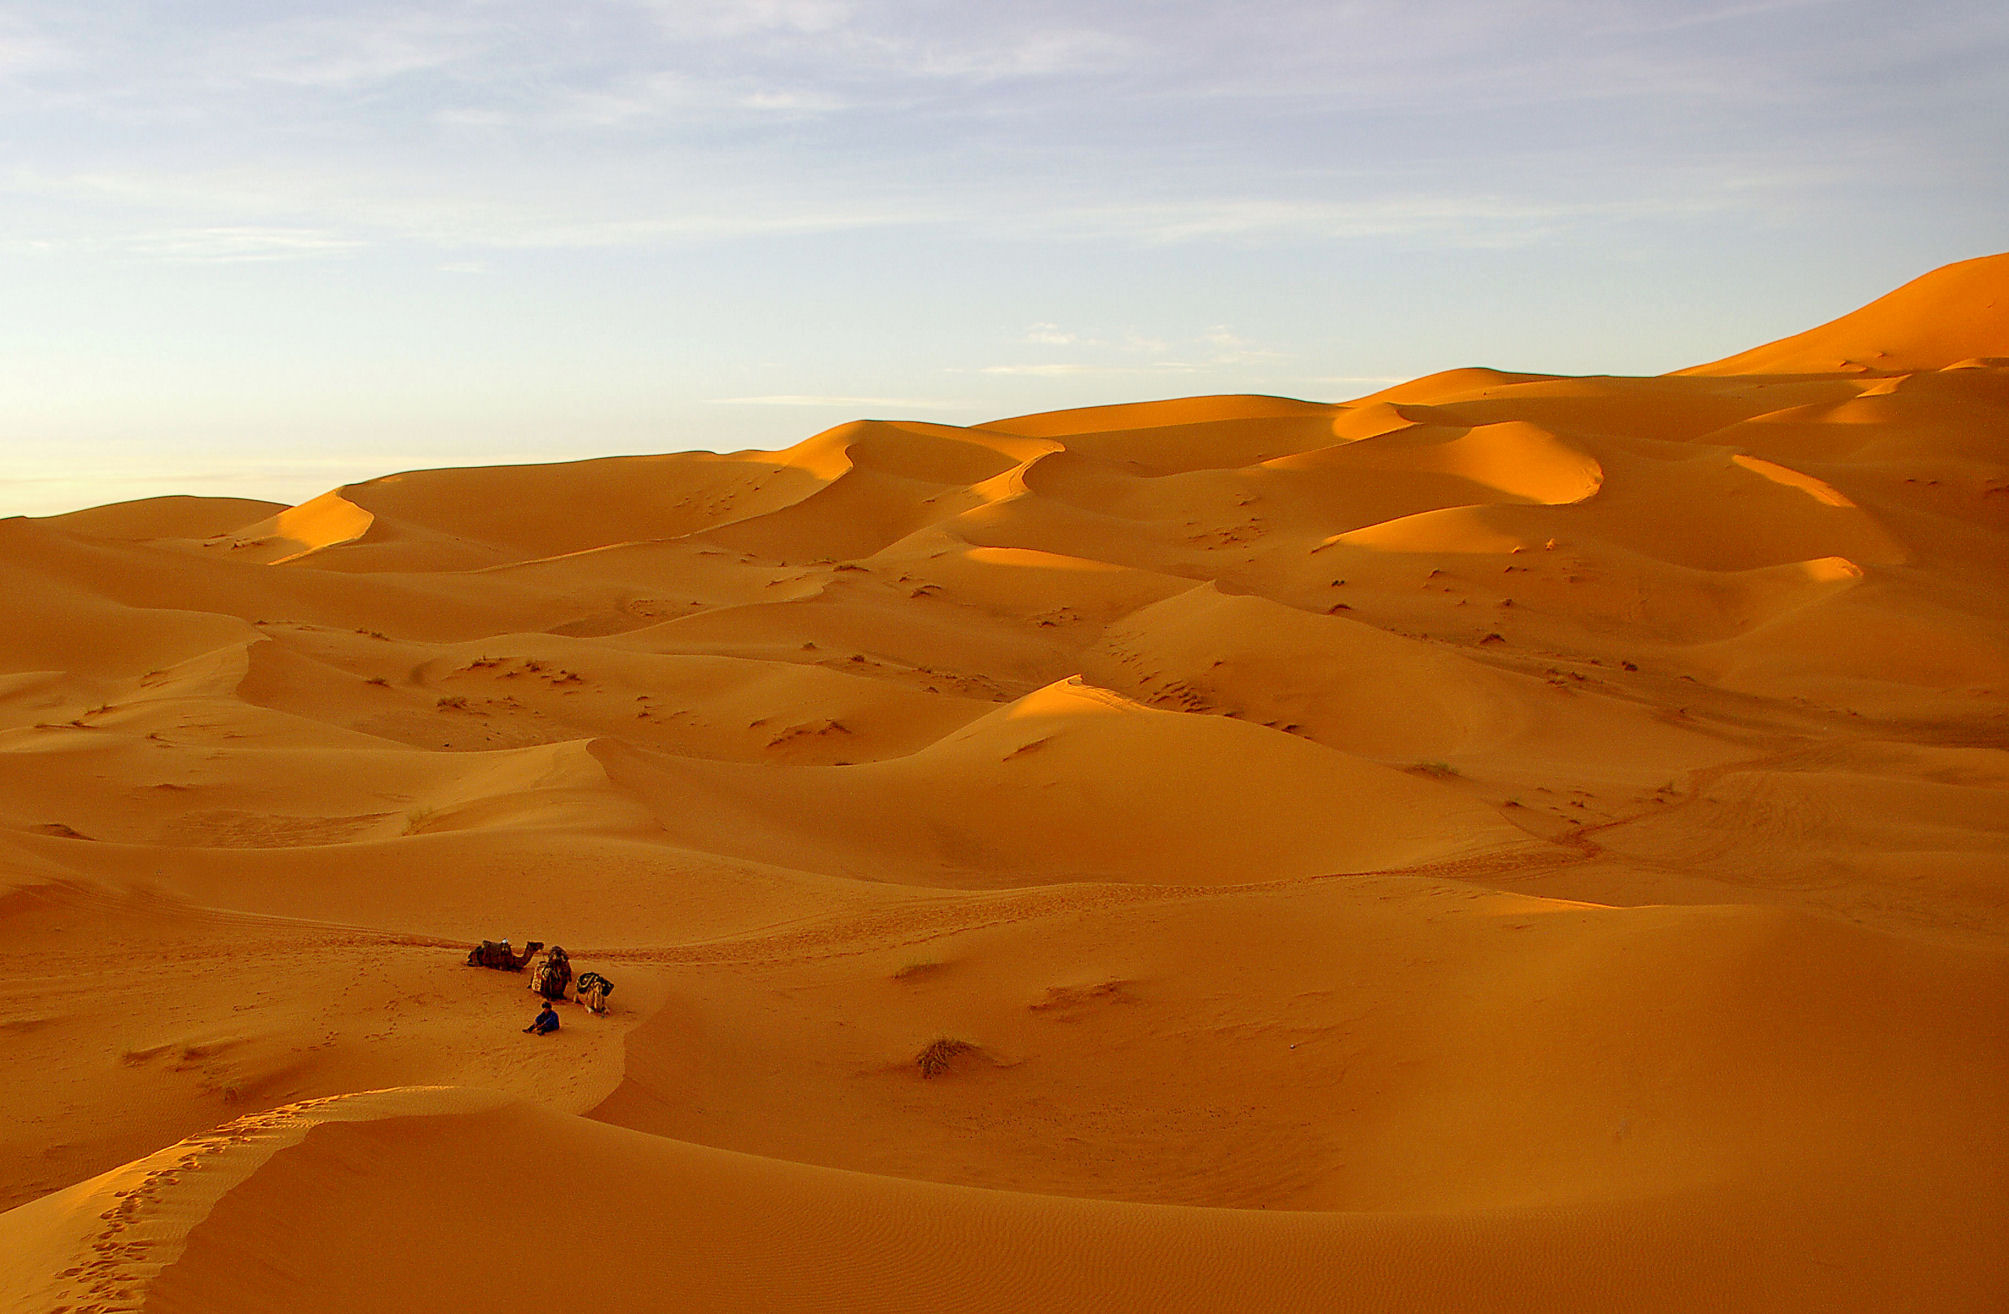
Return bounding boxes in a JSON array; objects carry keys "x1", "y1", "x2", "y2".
[{"x1": 595, "y1": 681, "x2": 1519, "y2": 886}]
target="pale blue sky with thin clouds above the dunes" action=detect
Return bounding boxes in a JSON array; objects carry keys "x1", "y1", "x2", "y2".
[{"x1": 0, "y1": 0, "x2": 2009, "y2": 514}]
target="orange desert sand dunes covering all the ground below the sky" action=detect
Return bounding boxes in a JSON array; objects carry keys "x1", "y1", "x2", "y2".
[{"x1": 0, "y1": 255, "x2": 2009, "y2": 1314}]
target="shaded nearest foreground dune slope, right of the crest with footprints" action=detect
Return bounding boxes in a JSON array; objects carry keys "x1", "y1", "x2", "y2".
[{"x1": 7, "y1": 1091, "x2": 1985, "y2": 1314}]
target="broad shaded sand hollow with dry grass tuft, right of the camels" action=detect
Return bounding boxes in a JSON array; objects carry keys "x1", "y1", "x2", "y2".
[{"x1": 593, "y1": 876, "x2": 2009, "y2": 1218}]
